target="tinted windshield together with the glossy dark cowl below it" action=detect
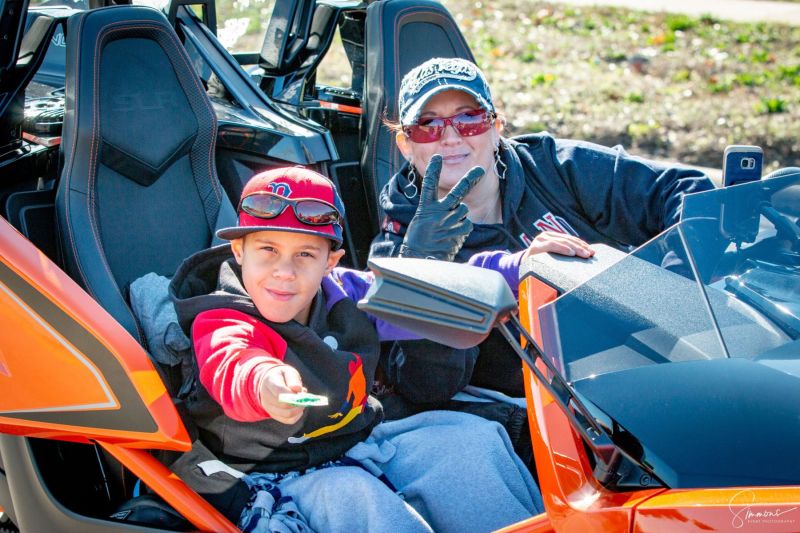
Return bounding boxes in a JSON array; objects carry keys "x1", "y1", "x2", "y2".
[{"x1": 539, "y1": 172, "x2": 800, "y2": 487}]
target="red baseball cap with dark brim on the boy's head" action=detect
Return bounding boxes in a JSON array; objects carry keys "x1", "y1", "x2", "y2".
[{"x1": 217, "y1": 167, "x2": 344, "y2": 248}]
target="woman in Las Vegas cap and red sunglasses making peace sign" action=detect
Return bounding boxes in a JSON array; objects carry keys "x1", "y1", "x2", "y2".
[{"x1": 371, "y1": 58, "x2": 713, "y2": 396}]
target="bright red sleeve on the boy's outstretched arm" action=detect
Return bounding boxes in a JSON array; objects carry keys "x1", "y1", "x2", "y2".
[{"x1": 192, "y1": 309, "x2": 286, "y2": 422}]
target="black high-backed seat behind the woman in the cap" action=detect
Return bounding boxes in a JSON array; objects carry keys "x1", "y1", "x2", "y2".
[{"x1": 361, "y1": 0, "x2": 474, "y2": 230}]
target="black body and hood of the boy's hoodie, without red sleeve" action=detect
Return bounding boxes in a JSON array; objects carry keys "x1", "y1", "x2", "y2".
[{"x1": 170, "y1": 245, "x2": 382, "y2": 472}]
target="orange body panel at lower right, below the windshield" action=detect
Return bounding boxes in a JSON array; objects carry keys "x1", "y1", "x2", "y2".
[{"x1": 516, "y1": 277, "x2": 800, "y2": 533}]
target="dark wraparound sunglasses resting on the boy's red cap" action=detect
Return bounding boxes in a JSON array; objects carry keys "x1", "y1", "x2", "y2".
[{"x1": 237, "y1": 191, "x2": 342, "y2": 226}]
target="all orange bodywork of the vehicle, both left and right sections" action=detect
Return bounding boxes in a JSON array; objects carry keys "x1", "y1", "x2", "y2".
[{"x1": 0, "y1": 213, "x2": 800, "y2": 533}]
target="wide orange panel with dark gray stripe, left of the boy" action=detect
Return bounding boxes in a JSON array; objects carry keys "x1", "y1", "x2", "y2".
[{"x1": 0, "y1": 219, "x2": 191, "y2": 450}]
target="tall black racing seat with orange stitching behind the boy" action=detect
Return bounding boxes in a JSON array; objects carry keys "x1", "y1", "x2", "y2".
[{"x1": 56, "y1": 6, "x2": 235, "y2": 343}]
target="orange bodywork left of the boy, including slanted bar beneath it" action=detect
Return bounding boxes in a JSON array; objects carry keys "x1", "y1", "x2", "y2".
[{"x1": 0, "y1": 218, "x2": 238, "y2": 532}]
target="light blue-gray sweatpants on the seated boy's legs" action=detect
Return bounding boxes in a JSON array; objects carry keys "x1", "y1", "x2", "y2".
[{"x1": 245, "y1": 411, "x2": 543, "y2": 533}]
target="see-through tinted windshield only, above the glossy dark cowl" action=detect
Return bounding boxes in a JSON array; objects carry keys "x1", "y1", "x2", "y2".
[{"x1": 540, "y1": 170, "x2": 800, "y2": 381}]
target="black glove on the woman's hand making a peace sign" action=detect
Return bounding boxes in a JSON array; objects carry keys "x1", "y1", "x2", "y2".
[{"x1": 400, "y1": 154, "x2": 484, "y2": 261}]
